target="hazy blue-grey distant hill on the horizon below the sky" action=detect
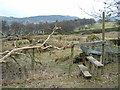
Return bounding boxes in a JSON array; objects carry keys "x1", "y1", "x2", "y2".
[{"x1": 0, "y1": 15, "x2": 79, "y2": 24}]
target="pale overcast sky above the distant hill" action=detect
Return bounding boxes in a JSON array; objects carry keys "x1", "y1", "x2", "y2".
[{"x1": 0, "y1": 0, "x2": 103, "y2": 18}]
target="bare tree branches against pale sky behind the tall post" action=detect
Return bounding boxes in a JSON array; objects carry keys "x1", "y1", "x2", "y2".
[{"x1": 79, "y1": 0, "x2": 120, "y2": 20}]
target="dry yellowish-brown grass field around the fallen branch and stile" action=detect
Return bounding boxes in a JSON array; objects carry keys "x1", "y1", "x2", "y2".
[{"x1": 0, "y1": 29, "x2": 119, "y2": 88}]
